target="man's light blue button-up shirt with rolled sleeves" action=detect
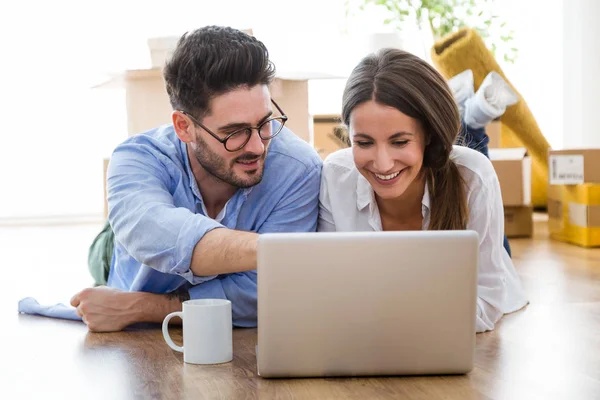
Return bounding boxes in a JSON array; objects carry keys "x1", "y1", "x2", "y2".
[{"x1": 107, "y1": 125, "x2": 322, "y2": 327}]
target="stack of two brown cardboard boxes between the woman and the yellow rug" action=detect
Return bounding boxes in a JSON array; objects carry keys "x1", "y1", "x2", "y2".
[{"x1": 489, "y1": 148, "x2": 533, "y2": 238}]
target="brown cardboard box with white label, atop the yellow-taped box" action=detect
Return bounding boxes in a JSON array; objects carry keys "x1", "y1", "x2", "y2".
[{"x1": 548, "y1": 149, "x2": 600, "y2": 185}]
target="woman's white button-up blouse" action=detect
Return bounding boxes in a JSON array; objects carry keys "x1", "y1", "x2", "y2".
[{"x1": 318, "y1": 146, "x2": 528, "y2": 332}]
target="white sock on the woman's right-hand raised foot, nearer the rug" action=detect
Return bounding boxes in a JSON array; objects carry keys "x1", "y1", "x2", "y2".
[{"x1": 464, "y1": 71, "x2": 519, "y2": 128}]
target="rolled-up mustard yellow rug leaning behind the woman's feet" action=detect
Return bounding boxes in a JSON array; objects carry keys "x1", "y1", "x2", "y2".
[{"x1": 431, "y1": 28, "x2": 550, "y2": 208}]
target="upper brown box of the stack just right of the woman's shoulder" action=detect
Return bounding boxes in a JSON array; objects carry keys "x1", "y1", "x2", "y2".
[{"x1": 489, "y1": 147, "x2": 531, "y2": 207}]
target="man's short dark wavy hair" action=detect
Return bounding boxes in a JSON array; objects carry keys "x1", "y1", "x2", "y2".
[{"x1": 163, "y1": 26, "x2": 275, "y2": 118}]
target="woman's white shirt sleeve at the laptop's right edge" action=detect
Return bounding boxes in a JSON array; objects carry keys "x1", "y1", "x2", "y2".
[{"x1": 468, "y1": 174, "x2": 513, "y2": 332}]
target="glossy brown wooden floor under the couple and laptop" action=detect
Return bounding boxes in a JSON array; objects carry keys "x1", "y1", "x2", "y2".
[{"x1": 0, "y1": 215, "x2": 600, "y2": 399}]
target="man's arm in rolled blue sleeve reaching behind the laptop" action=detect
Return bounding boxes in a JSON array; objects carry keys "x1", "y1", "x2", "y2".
[{"x1": 107, "y1": 143, "x2": 257, "y2": 285}]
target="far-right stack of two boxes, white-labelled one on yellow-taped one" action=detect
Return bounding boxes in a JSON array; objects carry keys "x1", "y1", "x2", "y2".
[{"x1": 548, "y1": 149, "x2": 600, "y2": 247}]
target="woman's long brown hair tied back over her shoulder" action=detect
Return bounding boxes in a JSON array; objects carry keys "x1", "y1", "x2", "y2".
[{"x1": 342, "y1": 49, "x2": 468, "y2": 230}]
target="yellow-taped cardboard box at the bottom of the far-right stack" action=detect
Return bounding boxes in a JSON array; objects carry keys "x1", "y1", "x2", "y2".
[{"x1": 548, "y1": 183, "x2": 600, "y2": 247}]
